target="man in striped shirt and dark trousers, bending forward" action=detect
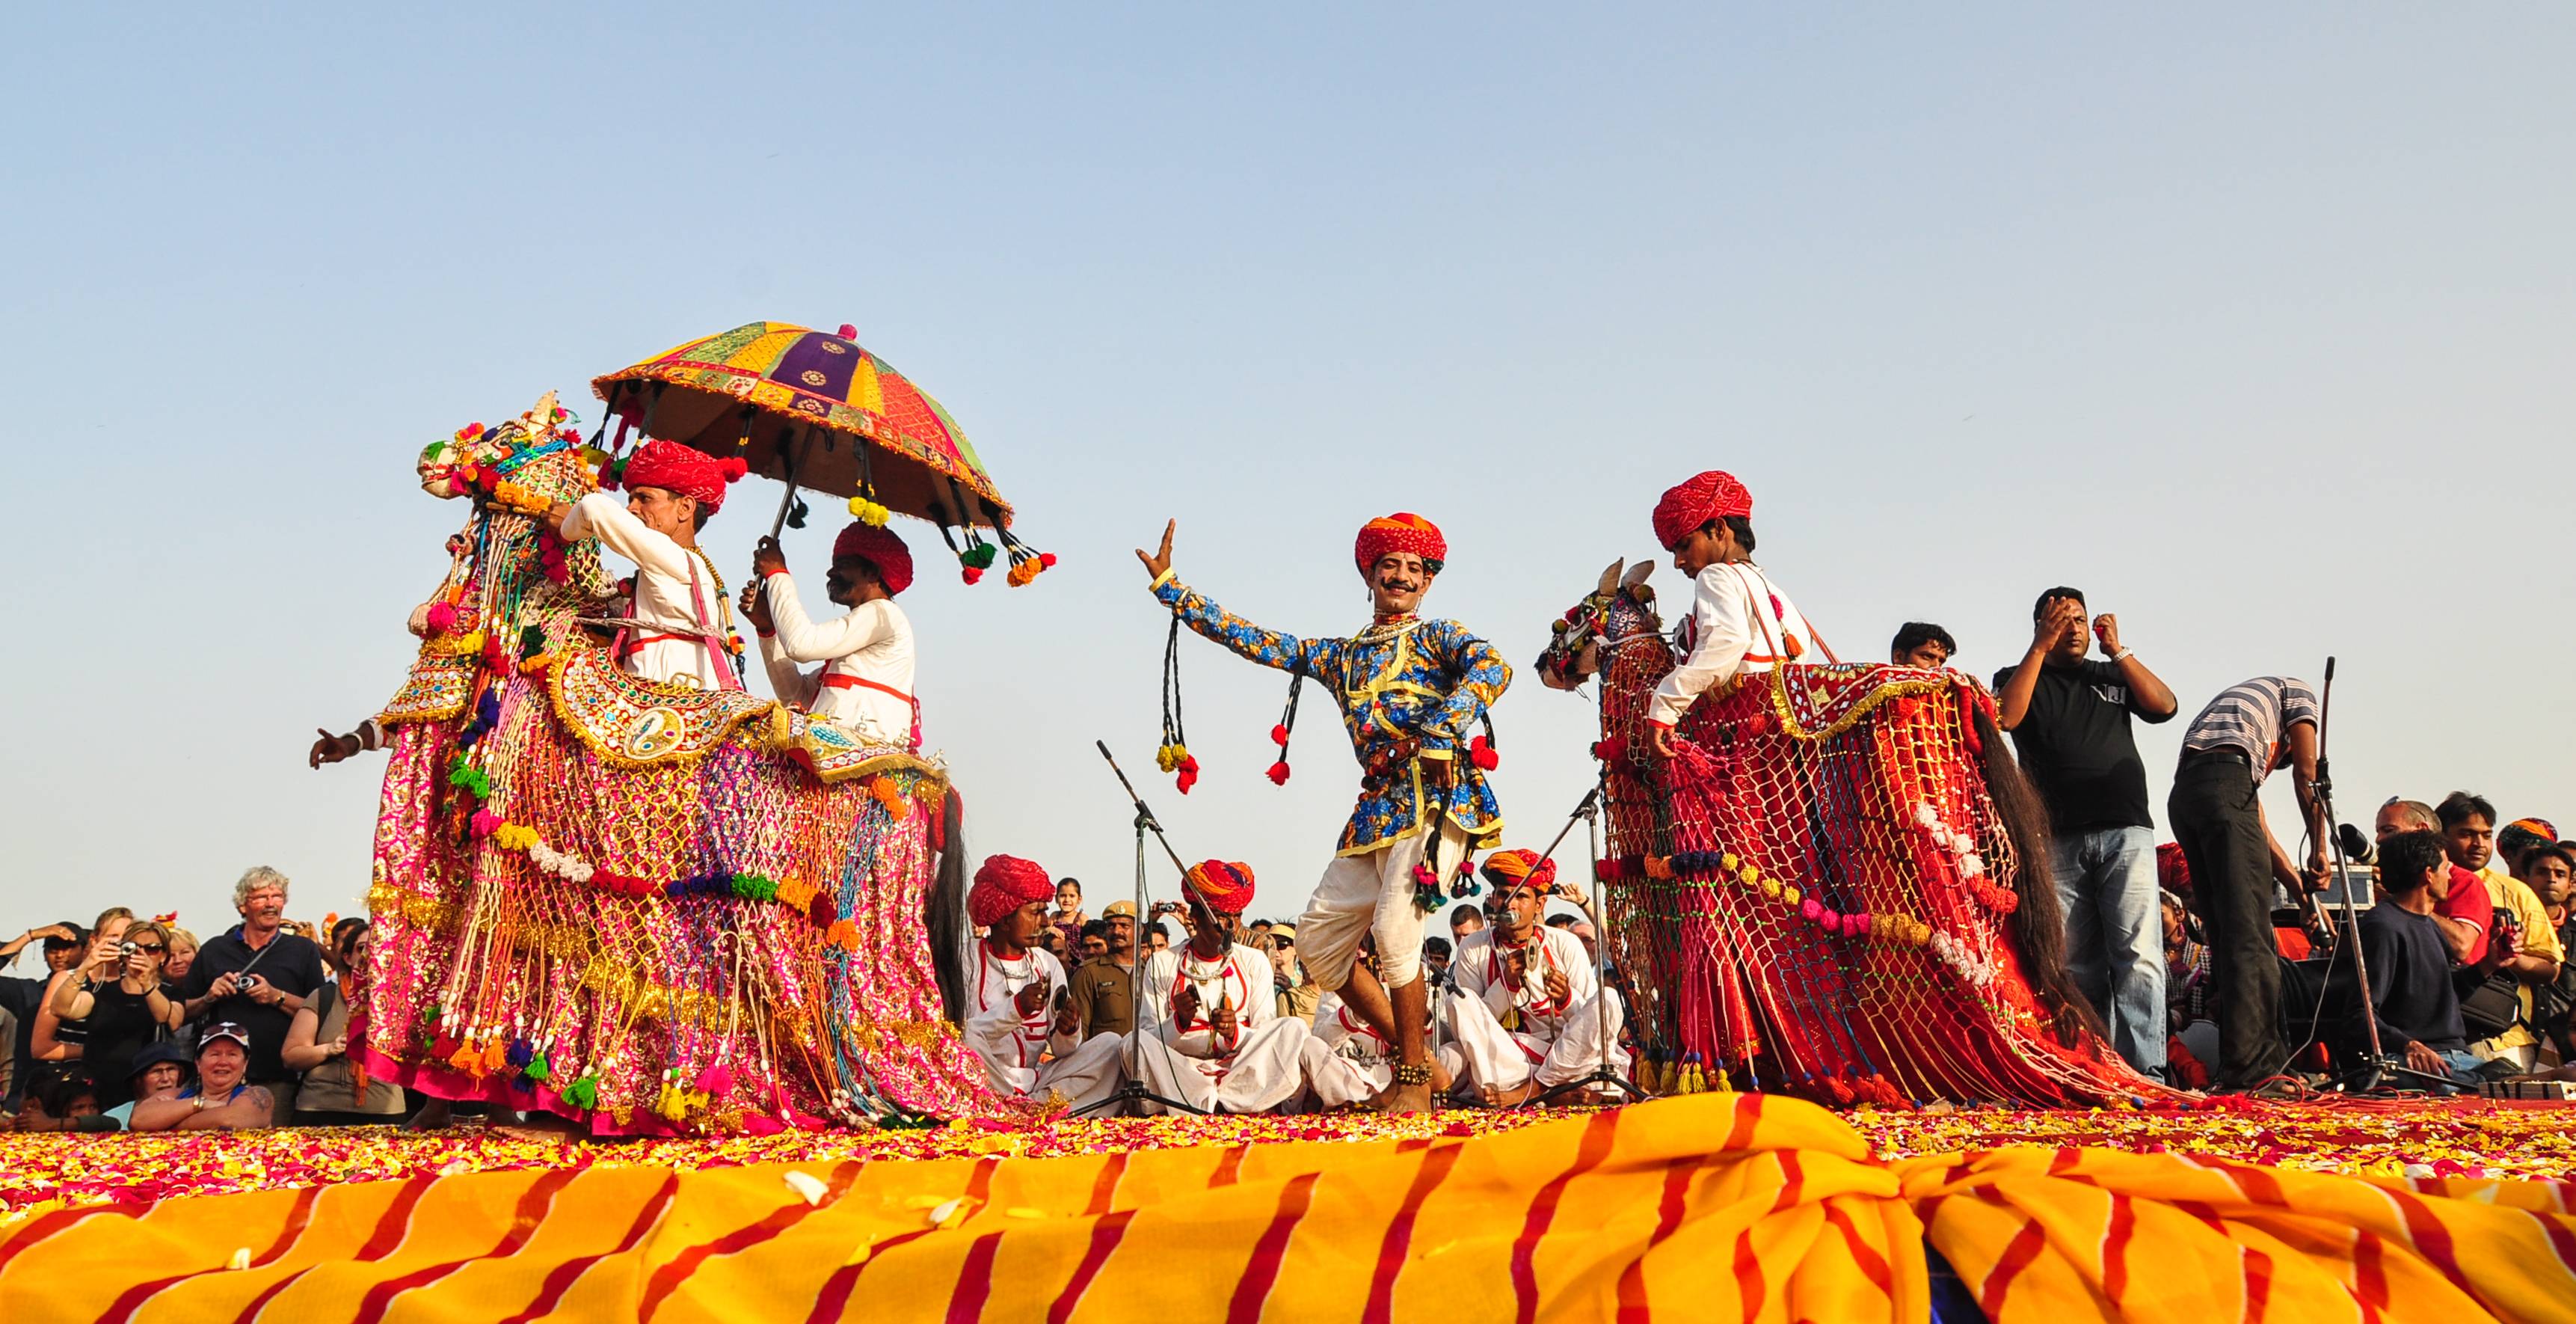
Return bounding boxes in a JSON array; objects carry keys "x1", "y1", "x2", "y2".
[{"x1": 2164, "y1": 675, "x2": 2326, "y2": 1090}]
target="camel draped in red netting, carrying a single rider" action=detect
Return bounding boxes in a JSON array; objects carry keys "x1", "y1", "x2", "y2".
[{"x1": 1594, "y1": 577, "x2": 2169, "y2": 1105}]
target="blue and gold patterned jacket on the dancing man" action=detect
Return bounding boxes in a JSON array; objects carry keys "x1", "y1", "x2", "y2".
[{"x1": 1154, "y1": 574, "x2": 1512, "y2": 850}]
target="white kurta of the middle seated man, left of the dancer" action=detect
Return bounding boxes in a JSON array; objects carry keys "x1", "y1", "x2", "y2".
[{"x1": 1136, "y1": 943, "x2": 1309, "y2": 1113}]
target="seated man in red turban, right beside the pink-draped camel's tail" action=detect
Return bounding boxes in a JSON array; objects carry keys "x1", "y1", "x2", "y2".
[{"x1": 966, "y1": 855, "x2": 1121, "y2": 1108}]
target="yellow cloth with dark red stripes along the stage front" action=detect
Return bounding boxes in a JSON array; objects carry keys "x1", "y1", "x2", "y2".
[{"x1": 0, "y1": 1095, "x2": 2576, "y2": 1324}]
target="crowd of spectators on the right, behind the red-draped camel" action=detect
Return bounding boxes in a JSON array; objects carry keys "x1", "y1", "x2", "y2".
[{"x1": 1937, "y1": 585, "x2": 2576, "y2": 1095}]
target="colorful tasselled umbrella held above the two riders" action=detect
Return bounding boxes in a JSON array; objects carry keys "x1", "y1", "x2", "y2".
[{"x1": 590, "y1": 322, "x2": 1054, "y2": 582}]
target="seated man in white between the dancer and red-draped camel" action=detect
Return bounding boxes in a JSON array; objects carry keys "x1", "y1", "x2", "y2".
[{"x1": 1451, "y1": 850, "x2": 1628, "y2": 1108}]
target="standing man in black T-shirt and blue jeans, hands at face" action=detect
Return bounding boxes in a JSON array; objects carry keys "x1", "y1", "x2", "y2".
[{"x1": 1994, "y1": 587, "x2": 2174, "y2": 1074}]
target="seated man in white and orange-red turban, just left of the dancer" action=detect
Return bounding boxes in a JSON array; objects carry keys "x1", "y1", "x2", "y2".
[{"x1": 1138, "y1": 860, "x2": 1306, "y2": 1113}]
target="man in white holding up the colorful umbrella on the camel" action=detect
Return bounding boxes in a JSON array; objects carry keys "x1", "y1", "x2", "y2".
[{"x1": 742, "y1": 521, "x2": 922, "y2": 750}]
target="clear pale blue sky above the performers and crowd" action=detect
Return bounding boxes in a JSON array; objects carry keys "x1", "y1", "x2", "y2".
[{"x1": 0, "y1": 5, "x2": 2576, "y2": 933}]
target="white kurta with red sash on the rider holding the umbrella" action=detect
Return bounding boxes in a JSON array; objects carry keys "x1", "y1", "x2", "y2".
[{"x1": 760, "y1": 569, "x2": 914, "y2": 750}]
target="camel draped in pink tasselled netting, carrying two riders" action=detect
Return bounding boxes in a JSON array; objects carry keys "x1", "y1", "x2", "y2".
[{"x1": 351, "y1": 394, "x2": 997, "y2": 1136}]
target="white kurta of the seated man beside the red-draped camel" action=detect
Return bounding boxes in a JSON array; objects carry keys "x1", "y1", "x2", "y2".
[{"x1": 1451, "y1": 925, "x2": 1628, "y2": 1090}]
